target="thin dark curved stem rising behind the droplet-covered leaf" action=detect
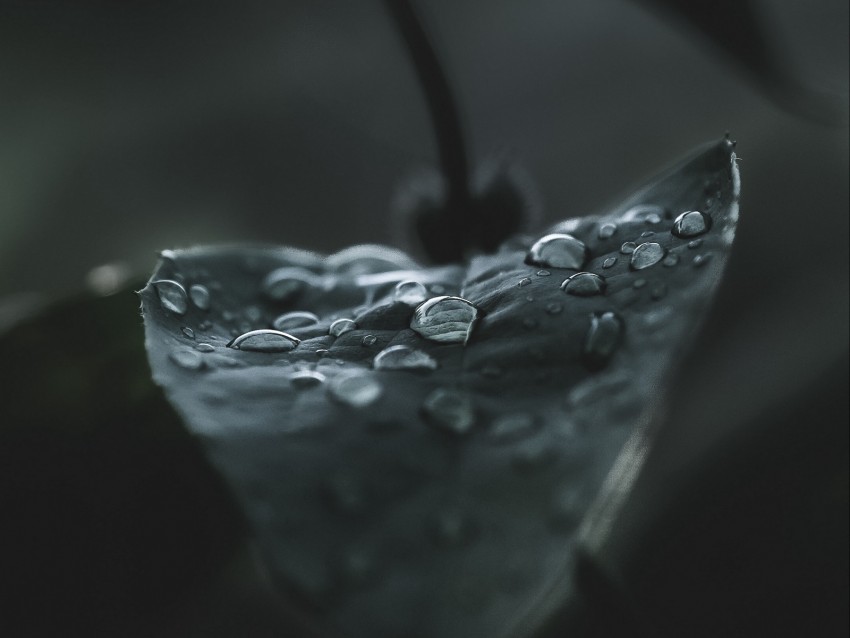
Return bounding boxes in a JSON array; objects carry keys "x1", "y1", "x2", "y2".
[{"x1": 384, "y1": 0, "x2": 470, "y2": 209}]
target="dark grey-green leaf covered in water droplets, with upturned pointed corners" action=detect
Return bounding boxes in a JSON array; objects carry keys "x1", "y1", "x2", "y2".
[{"x1": 141, "y1": 140, "x2": 739, "y2": 636}]
